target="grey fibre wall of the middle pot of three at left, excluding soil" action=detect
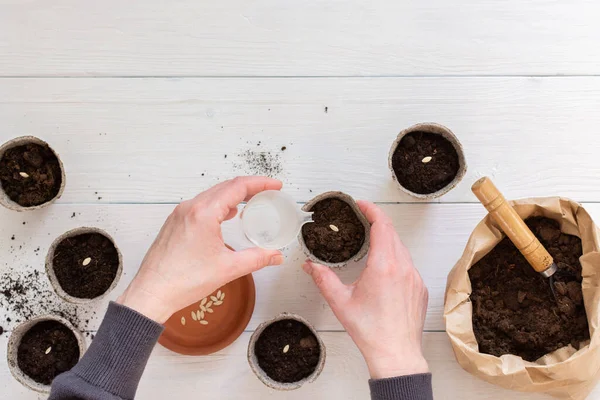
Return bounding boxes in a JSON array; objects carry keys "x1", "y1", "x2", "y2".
[{"x1": 46, "y1": 227, "x2": 123, "y2": 304}]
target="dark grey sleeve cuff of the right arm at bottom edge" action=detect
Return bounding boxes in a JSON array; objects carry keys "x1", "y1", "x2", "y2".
[{"x1": 369, "y1": 373, "x2": 433, "y2": 400}]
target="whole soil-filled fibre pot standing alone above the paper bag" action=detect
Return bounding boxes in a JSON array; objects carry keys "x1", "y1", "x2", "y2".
[{"x1": 388, "y1": 123, "x2": 467, "y2": 199}]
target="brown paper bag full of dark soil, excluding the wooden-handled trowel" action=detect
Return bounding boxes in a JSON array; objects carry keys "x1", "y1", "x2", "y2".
[{"x1": 444, "y1": 198, "x2": 600, "y2": 399}]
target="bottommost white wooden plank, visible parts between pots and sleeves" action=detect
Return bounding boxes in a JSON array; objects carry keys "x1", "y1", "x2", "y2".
[{"x1": 0, "y1": 332, "x2": 580, "y2": 400}]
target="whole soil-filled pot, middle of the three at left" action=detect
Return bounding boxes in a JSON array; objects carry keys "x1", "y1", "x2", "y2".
[{"x1": 46, "y1": 227, "x2": 123, "y2": 304}]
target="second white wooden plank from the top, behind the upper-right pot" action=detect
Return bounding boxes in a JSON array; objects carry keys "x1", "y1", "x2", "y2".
[{"x1": 0, "y1": 77, "x2": 600, "y2": 203}]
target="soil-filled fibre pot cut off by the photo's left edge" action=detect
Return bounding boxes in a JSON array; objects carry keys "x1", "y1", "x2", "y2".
[{"x1": 0, "y1": 136, "x2": 66, "y2": 211}]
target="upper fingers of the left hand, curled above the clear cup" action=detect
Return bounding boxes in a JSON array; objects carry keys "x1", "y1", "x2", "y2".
[{"x1": 203, "y1": 176, "x2": 283, "y2": 223}]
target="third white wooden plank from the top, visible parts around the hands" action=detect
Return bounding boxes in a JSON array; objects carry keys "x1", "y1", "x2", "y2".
[{"x1": 0, "y1": 204, "x2": 600, "y2": 331}]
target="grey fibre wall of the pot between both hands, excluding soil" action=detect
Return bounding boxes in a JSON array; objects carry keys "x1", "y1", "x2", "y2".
[{"x1": 298, "y1": 192, "x2": 371, "y2": 267}]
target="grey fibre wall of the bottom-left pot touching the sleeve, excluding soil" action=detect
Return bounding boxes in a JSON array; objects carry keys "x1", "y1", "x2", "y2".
[{"x1": 7, "y1": 315, "x2": 85, "y2": 393}]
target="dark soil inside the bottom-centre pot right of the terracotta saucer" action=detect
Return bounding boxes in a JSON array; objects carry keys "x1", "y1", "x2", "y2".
[{"x1": 254, "y1": 319, "x2": 321, "y2": 383}]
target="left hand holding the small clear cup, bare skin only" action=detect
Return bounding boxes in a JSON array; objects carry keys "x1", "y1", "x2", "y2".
[{"x1": 117, "y1": 176, "x2": 284, "y2": 324}]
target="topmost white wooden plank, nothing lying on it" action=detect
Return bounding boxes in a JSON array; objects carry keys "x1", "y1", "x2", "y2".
[{"x1": 0, "y1": 0, "x2": 600, "y2": 76}]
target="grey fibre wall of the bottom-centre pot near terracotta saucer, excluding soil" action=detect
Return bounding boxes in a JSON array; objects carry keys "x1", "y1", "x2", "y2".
[{"x1": 248, "y1": 313, "x2": 326, "y2": 390}]
